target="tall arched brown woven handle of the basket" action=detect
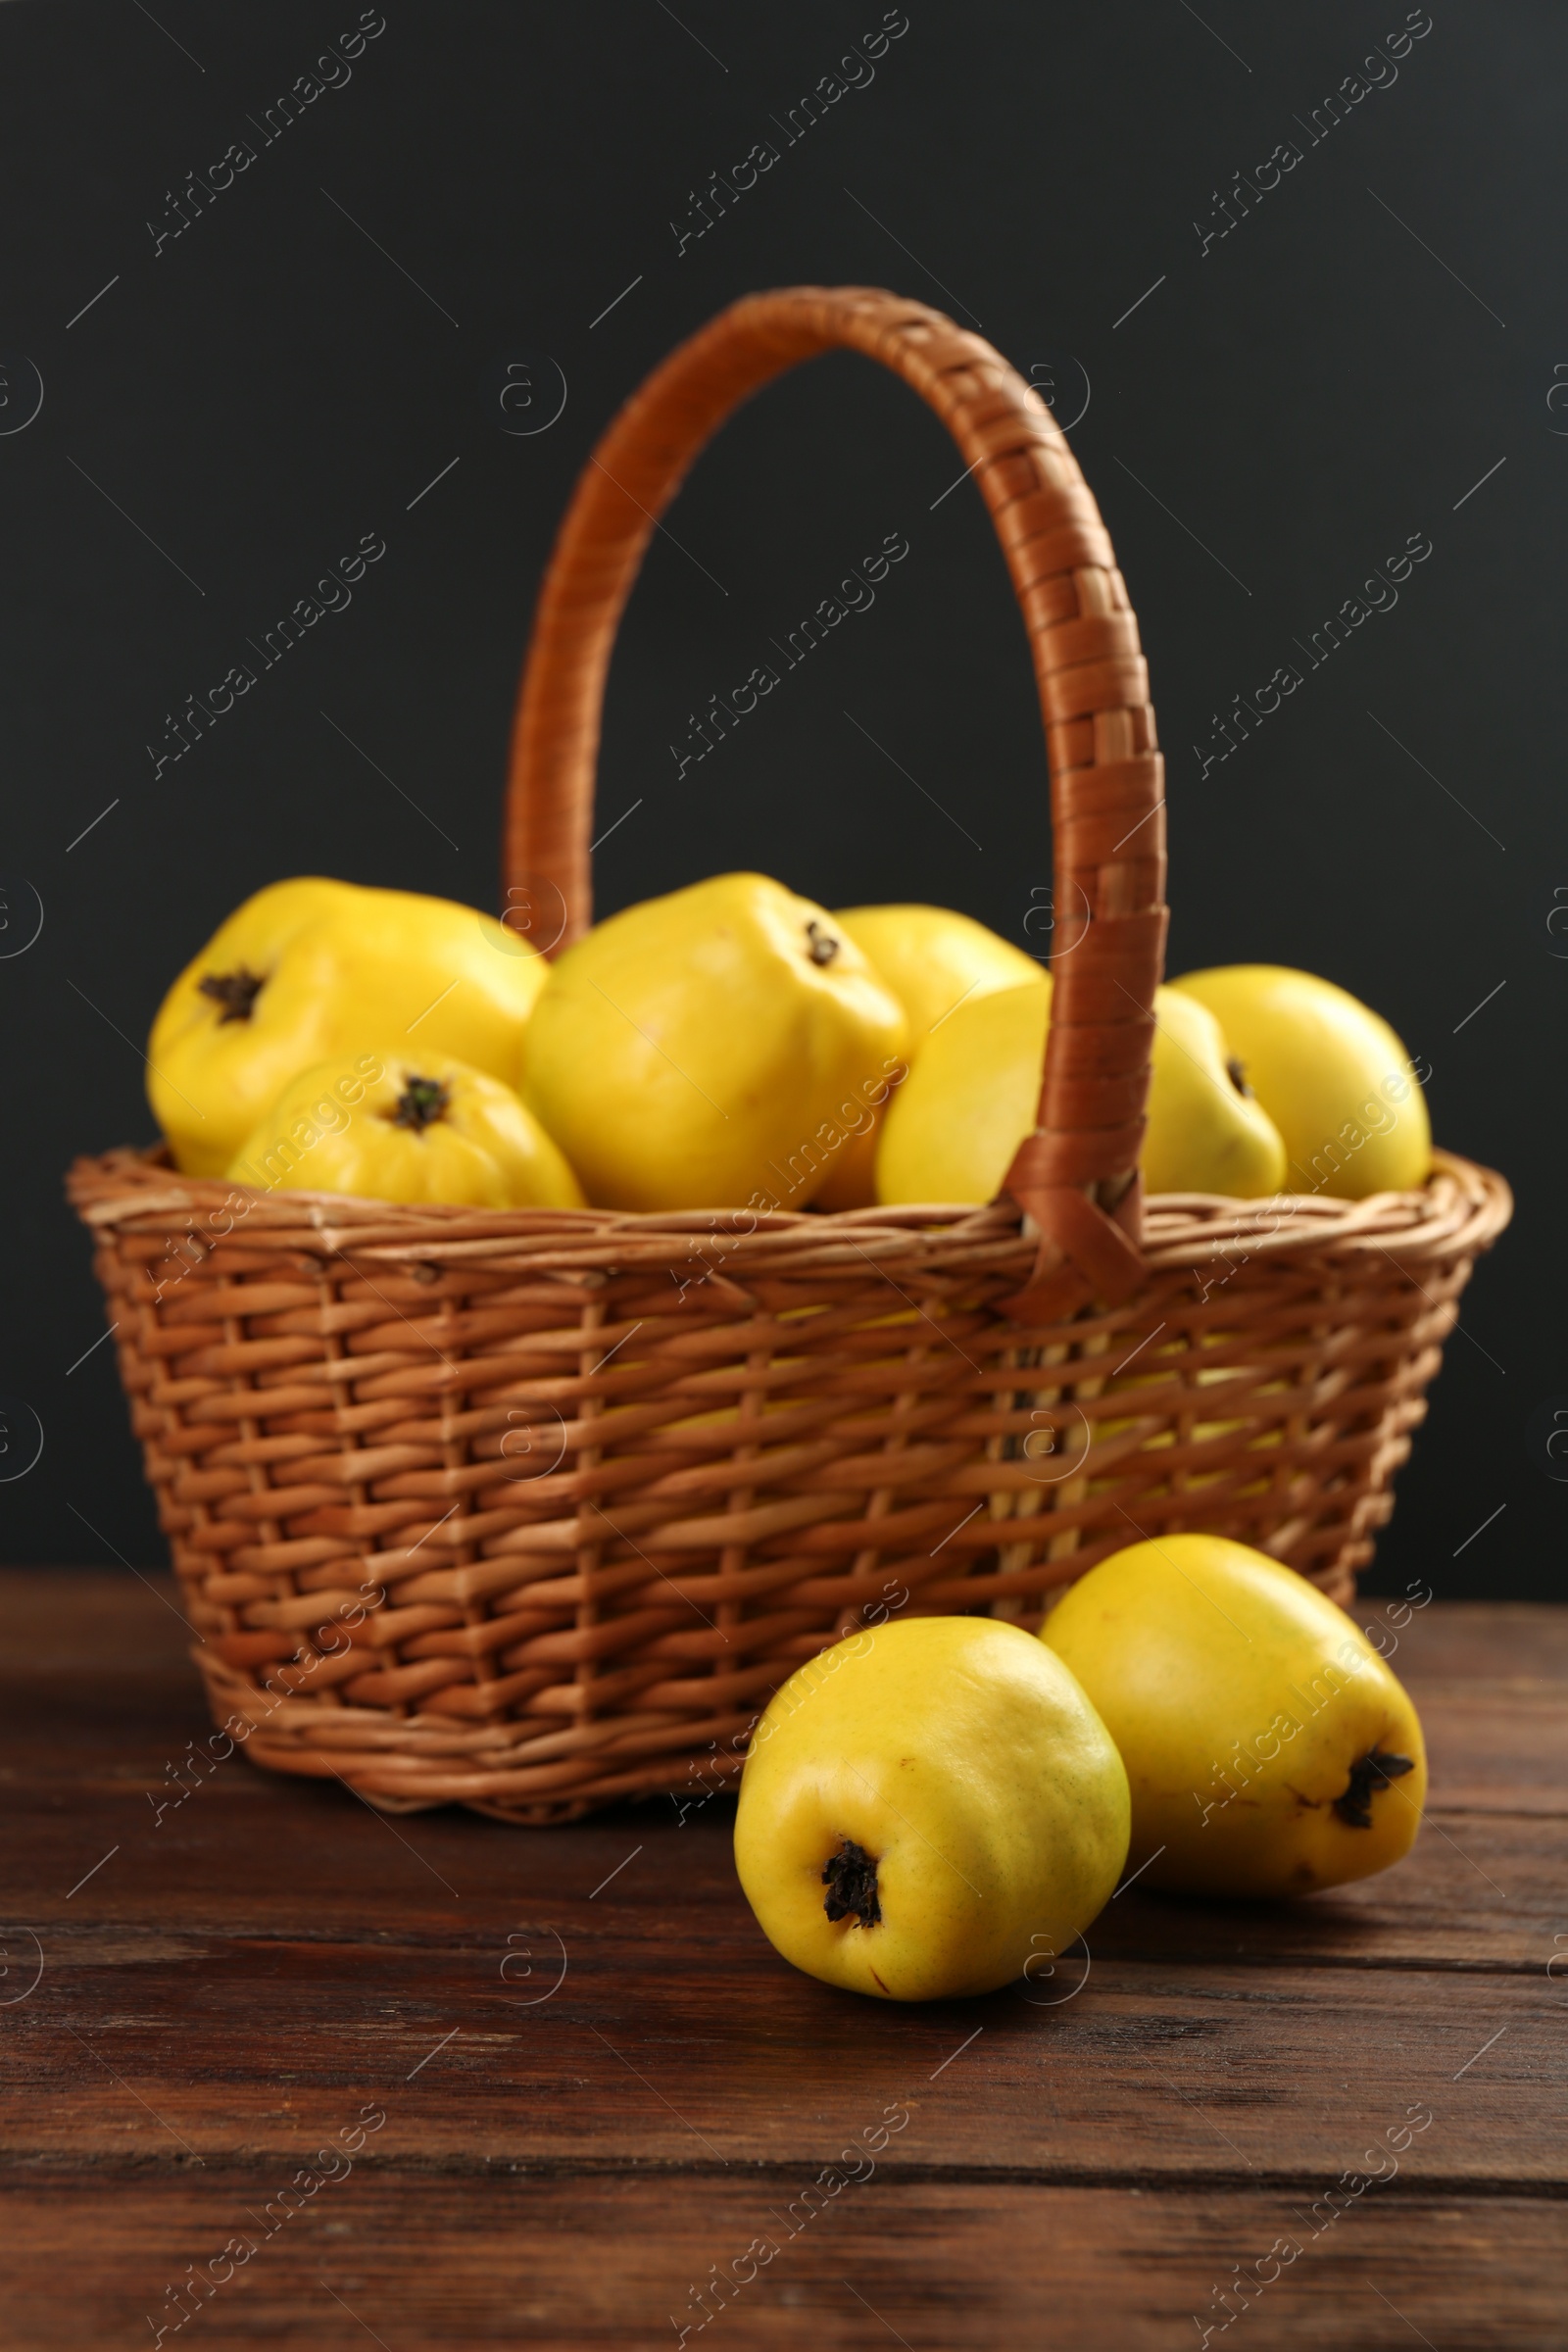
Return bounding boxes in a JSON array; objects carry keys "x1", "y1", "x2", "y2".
[{"x1": 503, "y1": 287, "x2": 1166, "y2": 1322}]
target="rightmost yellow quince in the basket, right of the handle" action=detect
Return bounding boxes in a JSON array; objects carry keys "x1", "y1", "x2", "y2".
[{"x1": 1171, "y1": 964, "x2": 1432, "y2": 1200}]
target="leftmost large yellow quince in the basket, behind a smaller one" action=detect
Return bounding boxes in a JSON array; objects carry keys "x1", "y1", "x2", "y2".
[{"x1": 148, "y1": 877, "x2": 548, "y2": 1176}]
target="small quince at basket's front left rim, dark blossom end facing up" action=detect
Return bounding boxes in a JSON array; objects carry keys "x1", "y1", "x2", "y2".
[{"x1": 228, "y1": 1047, "x2": 583, "y2": 1209}]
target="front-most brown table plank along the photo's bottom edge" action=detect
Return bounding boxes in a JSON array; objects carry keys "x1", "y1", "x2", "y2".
[{"x1": 0, "y1": 2164, "x2": 1568, "y2": 2352}]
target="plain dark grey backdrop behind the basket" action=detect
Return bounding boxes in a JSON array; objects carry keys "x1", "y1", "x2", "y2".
[{"x1": 0, "y1": 0, "x2": 1568, "y2": 1597}]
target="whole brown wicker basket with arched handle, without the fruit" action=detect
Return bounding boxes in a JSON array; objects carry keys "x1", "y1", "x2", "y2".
[{"x1": 71, "y1": 287, "x2": 1509, "y2": 1823}]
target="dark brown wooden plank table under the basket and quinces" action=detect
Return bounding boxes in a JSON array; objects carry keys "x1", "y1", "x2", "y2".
[{"x1": 0, "y1": 1571, "x2": 1568, "y2": 2352}]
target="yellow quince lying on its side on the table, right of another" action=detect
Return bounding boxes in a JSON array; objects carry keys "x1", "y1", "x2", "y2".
[{"x1": 1039, "y1": 1536, "x2": 1427, "y2": 1895}]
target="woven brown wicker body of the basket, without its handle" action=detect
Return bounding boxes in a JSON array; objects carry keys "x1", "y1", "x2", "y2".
[{"x1": 73, "y1": 1152, "x2": 1507, "y2": 1821}]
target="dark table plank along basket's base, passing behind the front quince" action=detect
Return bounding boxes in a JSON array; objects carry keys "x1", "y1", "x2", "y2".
[{"x1": 0, "y1": 1740, "x2": 1568, "y2": 1937}]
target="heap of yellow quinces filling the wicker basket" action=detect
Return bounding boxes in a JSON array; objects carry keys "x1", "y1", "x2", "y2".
[{"x1": 148, "y1": 872, "x2": 1432, "y2": 1213}]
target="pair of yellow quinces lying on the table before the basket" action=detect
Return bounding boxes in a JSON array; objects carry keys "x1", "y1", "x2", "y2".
[{"x1": 736, "y1": 1536, "x2": 1427, "y2": 2004}]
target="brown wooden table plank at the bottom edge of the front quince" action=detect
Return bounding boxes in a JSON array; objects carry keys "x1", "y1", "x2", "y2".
[{"x1": 0, "y1": 1900, "x2": 1568, "y2": 2182}]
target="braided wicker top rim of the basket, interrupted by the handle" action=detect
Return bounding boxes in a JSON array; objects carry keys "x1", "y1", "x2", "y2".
[{"x1": 66, "y1": 1143, "x2": 1514, "y2": 1282}]
